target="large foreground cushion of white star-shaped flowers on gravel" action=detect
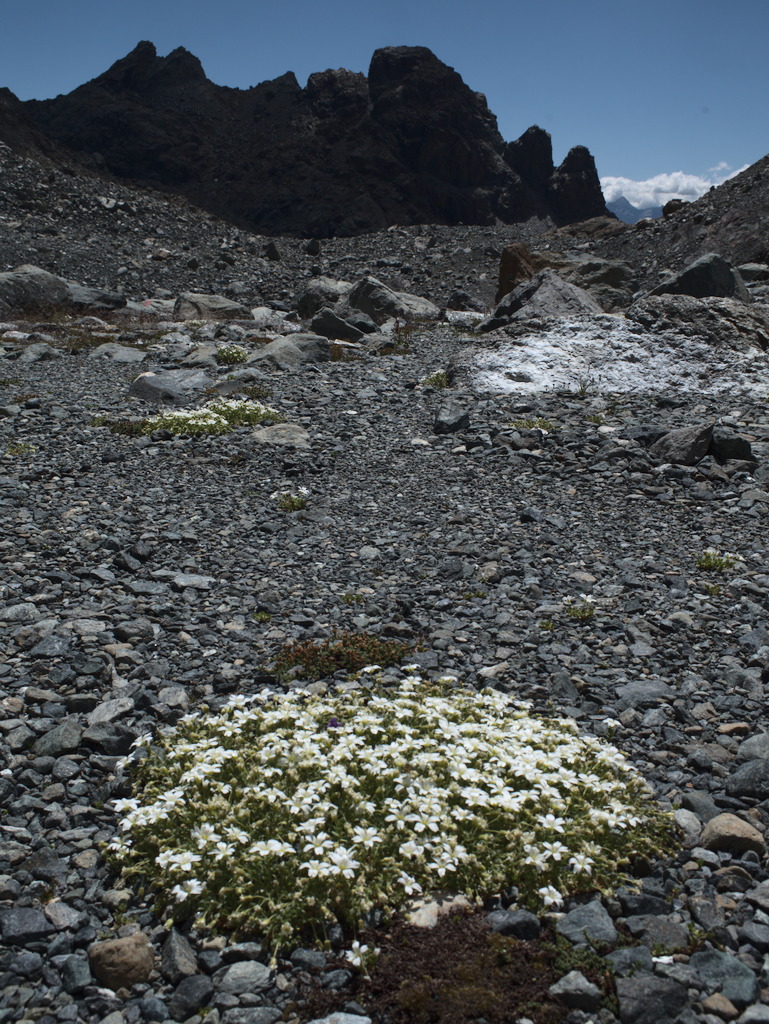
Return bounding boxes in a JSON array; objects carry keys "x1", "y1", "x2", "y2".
[{"x1": 109, "y1": 673, "x2": 667, "y2": 942}]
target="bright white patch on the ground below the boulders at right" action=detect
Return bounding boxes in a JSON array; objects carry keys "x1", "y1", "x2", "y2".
[{"x1": 472, "y1": 314, "x2": 769, "y2": 396}]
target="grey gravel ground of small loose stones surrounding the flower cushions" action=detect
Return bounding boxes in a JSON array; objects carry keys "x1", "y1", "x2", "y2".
[{"x1": 0, "y1": 311, "x2": 769, "y2": 1024}]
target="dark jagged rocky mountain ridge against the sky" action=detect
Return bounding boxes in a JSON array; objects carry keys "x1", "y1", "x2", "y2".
[{"x1": 0, "y1": 42, "x2": 606, "y2": 237}]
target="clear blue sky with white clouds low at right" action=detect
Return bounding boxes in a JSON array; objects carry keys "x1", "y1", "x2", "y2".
[{"x1": 0, "y1": 0, "x2": 769, "y2": 205}]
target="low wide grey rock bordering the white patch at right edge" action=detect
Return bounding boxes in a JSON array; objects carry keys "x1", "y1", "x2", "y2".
[{"x1": 626, "y1": 295, "x2": 769, "y2": 352}]
